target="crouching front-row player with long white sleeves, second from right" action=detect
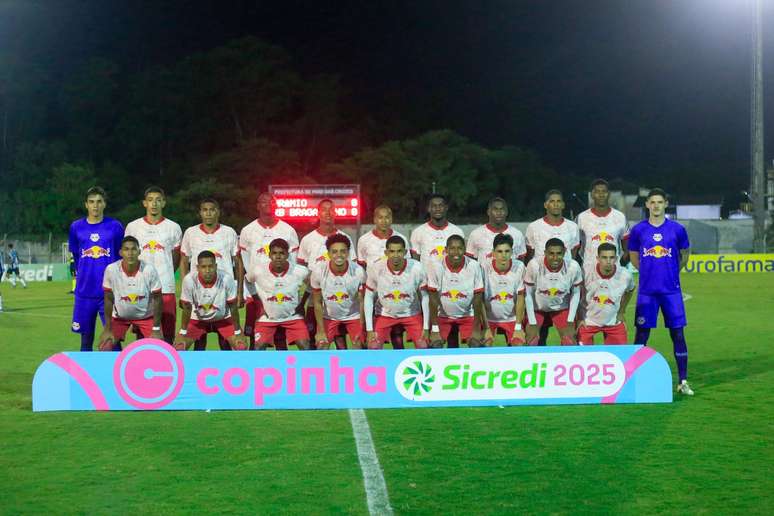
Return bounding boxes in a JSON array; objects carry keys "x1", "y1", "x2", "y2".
[{"x1": 524, "y1": 238, "x2": 583, "y2": 346}]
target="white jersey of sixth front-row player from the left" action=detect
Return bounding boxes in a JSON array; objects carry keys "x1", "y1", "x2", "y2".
[{"x1": 427, "y1": 256, "x2": 484, "y2": 319}]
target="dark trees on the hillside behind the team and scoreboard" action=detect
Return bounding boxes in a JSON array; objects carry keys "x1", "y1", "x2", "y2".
[{"x1": 0, "y1": 37, "x2": 744, "y2": 234}]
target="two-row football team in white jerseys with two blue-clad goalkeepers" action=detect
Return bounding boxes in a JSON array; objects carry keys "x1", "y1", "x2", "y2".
[{"x1": 66, "y1": 179, "x2": 693, "y2": 395}]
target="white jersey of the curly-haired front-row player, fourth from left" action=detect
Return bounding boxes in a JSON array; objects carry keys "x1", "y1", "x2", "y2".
[{"x1": 309, "y1": 262, "x2": 365, "y2": 321}]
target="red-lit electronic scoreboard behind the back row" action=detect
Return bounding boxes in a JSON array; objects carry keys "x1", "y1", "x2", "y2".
[{"x1": 269, "y1": 185, "x2": 362, "y2": 223}]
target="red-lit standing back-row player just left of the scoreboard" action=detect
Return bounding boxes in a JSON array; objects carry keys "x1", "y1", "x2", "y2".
[{"x1": 237, "y1": 192, "x2": 298, "y2": 344}]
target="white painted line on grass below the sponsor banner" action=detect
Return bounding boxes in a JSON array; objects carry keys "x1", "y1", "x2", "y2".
[{"x1": 349, "y1": 409, "x2": 392, "y2": 515}]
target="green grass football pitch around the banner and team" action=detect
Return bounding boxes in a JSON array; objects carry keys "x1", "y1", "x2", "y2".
[{"x1": 0, "y1": 274, "x2": 774, "y2": 514}]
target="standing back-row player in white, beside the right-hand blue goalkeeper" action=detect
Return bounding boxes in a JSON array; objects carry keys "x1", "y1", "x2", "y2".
[{"x1": 577, "y1": 179, "x2": 629, "y2": 274}]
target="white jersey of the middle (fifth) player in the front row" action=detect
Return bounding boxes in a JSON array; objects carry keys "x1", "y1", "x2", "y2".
[{"x1": 366, "y1": 258, "x2": 427, "y2": 318}]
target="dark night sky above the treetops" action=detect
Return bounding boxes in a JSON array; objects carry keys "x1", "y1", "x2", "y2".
[{"x1": 0, "y1": 0, "x2": 774, "y2": 177}]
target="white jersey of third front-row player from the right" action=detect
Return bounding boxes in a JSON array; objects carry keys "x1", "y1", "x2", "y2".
[{"x1": 483, "y1": 259, "x2": 526, "y2": 322}]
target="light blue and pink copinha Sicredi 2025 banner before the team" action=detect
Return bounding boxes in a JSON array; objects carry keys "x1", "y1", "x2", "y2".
[{"x1": 32, "y1": 339, "x2": 672, "y2": 412}]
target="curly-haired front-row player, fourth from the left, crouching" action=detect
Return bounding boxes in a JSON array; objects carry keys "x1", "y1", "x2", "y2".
[{"x1": 309, "y1": 233, "x2": 366, "y2": 349}]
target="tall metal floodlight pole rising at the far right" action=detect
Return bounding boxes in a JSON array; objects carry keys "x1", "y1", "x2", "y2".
[{"x1": 750, "y1": 0, "x2": 766, "y2": 253}]
